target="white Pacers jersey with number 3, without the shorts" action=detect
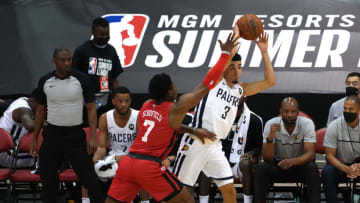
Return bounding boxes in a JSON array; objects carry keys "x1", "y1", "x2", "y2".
[{"x1": 191, "y1": 79, "x2": 243, "y2": 141}]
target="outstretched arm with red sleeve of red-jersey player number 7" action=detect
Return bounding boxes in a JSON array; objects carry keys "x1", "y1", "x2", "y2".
[{"x1": 168, "y1": 34, "x2": 239, "y2": 129}]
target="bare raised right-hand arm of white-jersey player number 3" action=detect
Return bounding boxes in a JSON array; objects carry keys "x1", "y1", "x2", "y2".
[{"x1": 242, "y1": 32, "x2": 275, "y2": 96}]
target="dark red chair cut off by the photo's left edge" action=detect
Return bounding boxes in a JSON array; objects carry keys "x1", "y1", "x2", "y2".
[{"x1": 0, "y1": 128, "x2": 14, "y2": 202}]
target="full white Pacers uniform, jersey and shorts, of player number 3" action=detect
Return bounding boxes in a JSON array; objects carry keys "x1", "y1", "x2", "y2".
[{"x1": 173, "y1": 79, "x2": 243, "y2": 187}]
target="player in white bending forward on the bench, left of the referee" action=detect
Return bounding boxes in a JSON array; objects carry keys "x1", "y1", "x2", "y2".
[{"x1": 0, "y1": 90, "x2": 37, "y2": 168}]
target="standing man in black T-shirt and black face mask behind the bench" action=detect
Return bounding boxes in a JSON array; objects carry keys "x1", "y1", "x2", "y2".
[{"x1": 72, "y1": 18, "x2": 123, "y2": 112}]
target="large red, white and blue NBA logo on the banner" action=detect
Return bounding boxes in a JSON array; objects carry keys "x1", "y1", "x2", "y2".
[{"x1": 103, "y1": 14, "x2": 149, "y2": 68}]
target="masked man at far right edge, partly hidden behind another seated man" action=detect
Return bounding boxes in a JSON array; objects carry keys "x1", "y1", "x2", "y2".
[{"x1": 326, "y1": 72, "x2": 360, "y2": 126}]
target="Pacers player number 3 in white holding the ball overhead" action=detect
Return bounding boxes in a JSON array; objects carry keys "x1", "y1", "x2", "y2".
[{"x1": 173, "y1": 33, "x2": 275, "y2": 203}]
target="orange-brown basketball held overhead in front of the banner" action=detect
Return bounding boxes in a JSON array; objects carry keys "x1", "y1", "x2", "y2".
[{"x1": 234, "y1": 14, "x2": 264, "y2": 40}]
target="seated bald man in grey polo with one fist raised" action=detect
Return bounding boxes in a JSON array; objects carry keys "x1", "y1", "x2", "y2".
[{"x1": 255, "y1": 97, "x2": 320, "y2": 203}]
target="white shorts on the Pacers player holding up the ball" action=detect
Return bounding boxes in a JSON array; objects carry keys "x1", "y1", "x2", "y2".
[{"x1": 173, "y1": 134, "x2": 233, "y2": 187}]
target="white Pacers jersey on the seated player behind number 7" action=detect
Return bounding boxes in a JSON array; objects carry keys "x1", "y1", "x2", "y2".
[{"x1": 106, "y1": 108, "x2": 139, "y2": 156}]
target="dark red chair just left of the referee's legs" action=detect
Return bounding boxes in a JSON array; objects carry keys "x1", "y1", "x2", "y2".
[{"x1": 10, "y1": 132, "x2": 43, "y2": 202}]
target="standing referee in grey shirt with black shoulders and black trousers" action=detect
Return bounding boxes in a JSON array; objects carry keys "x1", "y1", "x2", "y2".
[{"x1": 30, "y1": 48, "x2": 104, "y2": 203}]
